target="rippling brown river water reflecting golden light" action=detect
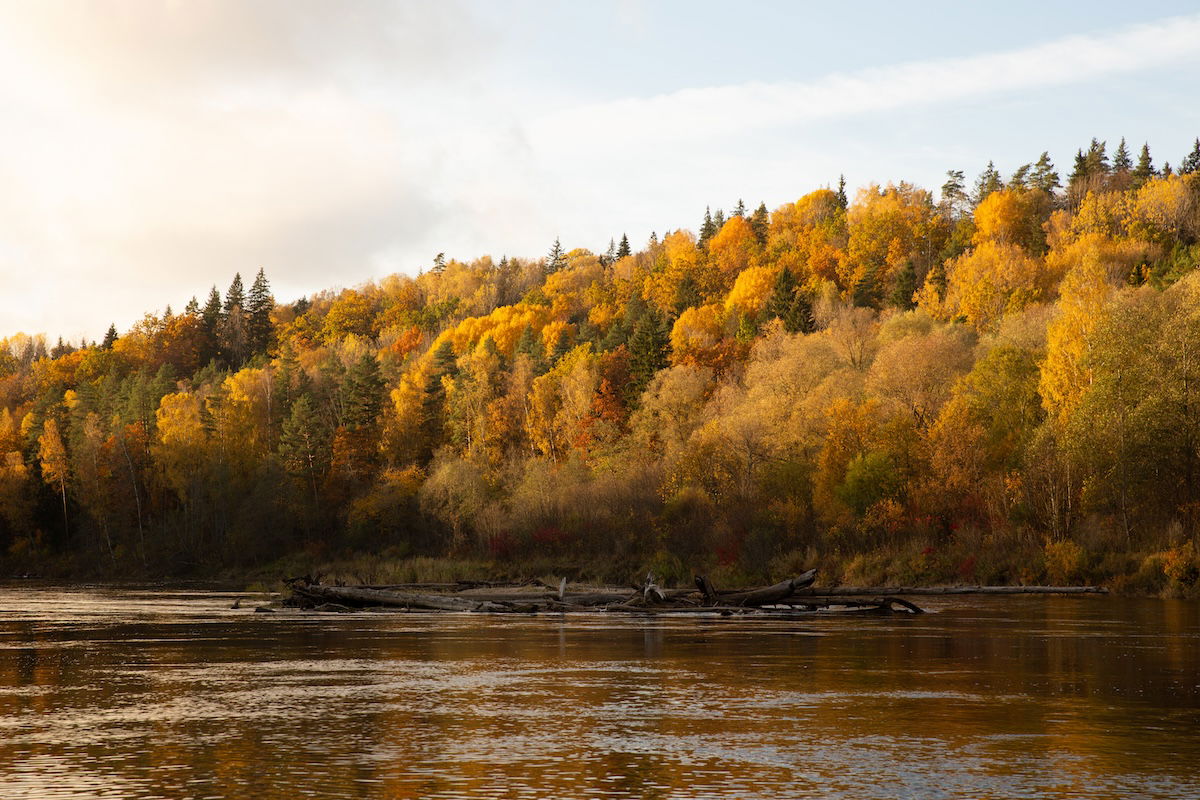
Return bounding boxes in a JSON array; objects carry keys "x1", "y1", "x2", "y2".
[{"x1": 0, "y1": 588, "x2": 1200, "y2": 800}]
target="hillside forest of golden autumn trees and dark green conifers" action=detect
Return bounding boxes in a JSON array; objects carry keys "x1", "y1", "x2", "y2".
[{"x1": 0, "y1": 139, "x2": 1200, "y2": 593}]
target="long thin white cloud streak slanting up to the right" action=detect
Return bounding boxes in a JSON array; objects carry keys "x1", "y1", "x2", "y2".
[{"x1": 533, "y1": 16, "x2": 1200, "y2": 148}]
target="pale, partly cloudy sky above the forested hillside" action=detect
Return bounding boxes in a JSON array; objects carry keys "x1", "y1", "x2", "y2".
[{"x1": 0, "y1": 0, "x2": 1200, "y2": 342}]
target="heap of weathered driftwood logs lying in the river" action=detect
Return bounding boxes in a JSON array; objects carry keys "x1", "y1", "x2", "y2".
[{"x1": 284, "y1": 570, "x2": 923, "y2": 616}]
